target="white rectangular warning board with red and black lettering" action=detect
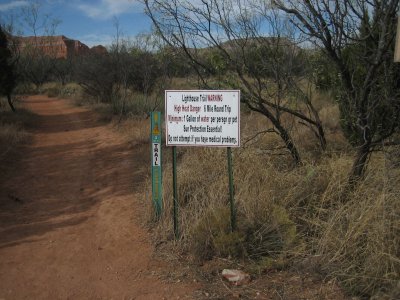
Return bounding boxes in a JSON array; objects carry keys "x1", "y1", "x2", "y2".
[{"x1": 165, "y1": 90, "x2": 240, "y2": 147}]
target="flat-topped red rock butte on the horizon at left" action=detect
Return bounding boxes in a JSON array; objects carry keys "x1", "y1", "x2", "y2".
[{"x1": 17, "y1": 35, "x2": 107, "y2": 58}]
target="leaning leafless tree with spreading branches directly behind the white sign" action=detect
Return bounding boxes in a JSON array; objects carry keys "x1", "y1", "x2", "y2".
[{"x1": 143, "y1": 0, "x2": 326, "y2": 163}]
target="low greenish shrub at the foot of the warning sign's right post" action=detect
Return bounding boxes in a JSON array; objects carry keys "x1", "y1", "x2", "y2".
[{"x1": 192, "y1": 205, "x2": 298, "y2": 260}]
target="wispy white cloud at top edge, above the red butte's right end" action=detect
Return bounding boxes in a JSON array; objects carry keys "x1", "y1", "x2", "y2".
[{"x1": 77, "y1": 0, "x2": 139, "y2": 19}]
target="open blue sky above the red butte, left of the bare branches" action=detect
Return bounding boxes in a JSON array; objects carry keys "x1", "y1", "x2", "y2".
[{"x1": 0, "y1": 0, "x2": 151, "y2": 46}]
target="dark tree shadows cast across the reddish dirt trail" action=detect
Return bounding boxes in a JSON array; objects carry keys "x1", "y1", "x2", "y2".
[{"x1": 0, "y1": 95, "x2": 148, "y2": 248}]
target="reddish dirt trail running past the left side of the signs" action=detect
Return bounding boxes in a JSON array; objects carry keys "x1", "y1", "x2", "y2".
[{"x1": 0, "y1": 96, "x2": 196, "y2": 299}]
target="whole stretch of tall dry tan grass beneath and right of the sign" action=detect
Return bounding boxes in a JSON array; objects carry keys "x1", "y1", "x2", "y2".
[{"x1": 148, "y1": 139, "x2": 400, "y2": 299}]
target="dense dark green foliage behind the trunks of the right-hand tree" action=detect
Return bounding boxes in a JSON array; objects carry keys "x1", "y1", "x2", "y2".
[{"x1": 313, "y1": 11, "x2": 400, "y2": 147}]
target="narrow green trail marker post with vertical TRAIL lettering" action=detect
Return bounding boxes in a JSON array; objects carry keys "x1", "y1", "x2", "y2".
[{"x1": 151, "y1": 111, "x2": 162, "y2": 218}]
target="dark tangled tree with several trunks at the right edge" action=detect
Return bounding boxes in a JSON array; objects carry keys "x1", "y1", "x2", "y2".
[{"x1": 272, "y1": 0, "x2": 400, "y2": 184}]
